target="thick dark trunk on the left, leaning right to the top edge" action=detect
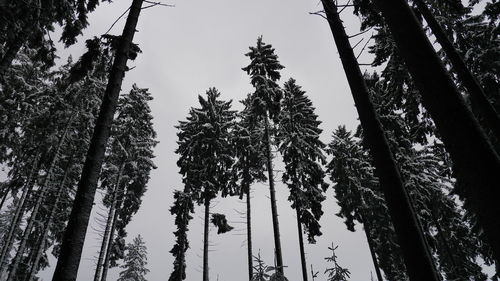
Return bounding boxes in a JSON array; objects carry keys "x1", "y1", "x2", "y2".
[{"x1": 52, "y1": 0, "x2": 143, "y2": 281}]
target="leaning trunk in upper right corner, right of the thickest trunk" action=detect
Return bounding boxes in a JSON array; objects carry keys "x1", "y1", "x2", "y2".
[{"x1": 413, "y1": 0, "x2": 500, "y2": 142}]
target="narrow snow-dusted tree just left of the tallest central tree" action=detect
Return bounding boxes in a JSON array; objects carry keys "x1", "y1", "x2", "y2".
[{"x1": 232, "y1": 96, "x2": 267, "y2": 280}]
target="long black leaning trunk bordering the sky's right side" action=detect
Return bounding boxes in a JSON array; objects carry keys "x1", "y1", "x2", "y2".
[{"x1": 322, "y1": 0, "x2": 440, "y2": 281}]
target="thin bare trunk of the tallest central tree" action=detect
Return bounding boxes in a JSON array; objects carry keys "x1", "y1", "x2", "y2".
[{"x1": 264, "y1": 112, "x2": 284, "y2": 275}]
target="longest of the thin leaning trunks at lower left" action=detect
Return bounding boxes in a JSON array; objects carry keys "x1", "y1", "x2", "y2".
[{"x1": 7, "y1": 116, "x2": 73, "y2": 281}]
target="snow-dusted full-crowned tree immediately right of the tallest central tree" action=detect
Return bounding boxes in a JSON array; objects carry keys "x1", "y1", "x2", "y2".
[{"x1": 276, "y1": 79, "x2": 328, "y2": 281}]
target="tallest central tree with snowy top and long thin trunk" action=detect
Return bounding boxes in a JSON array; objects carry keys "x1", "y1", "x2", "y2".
[{"x1": 243, "y1": 37, "x2": 284, "y2": 275}]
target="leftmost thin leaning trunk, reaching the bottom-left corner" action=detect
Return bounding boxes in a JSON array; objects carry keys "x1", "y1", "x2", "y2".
[{"x1": 0, "y1": 155, "x2": 40, "y2": 280}]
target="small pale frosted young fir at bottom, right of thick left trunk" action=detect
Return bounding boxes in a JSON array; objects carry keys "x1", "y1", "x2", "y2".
[{"x1": 118, "y1": 234, "x2": 149, "y2": 281}]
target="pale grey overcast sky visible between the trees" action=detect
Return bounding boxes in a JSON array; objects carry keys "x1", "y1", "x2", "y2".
[{"x1": 42, "y1": 0, "x2": 380, "y2": 281}]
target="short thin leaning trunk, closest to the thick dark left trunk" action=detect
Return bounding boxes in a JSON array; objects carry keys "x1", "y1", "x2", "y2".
[{"x1": 27, "y1": 164, "x2": 72, "y2": 281}]
